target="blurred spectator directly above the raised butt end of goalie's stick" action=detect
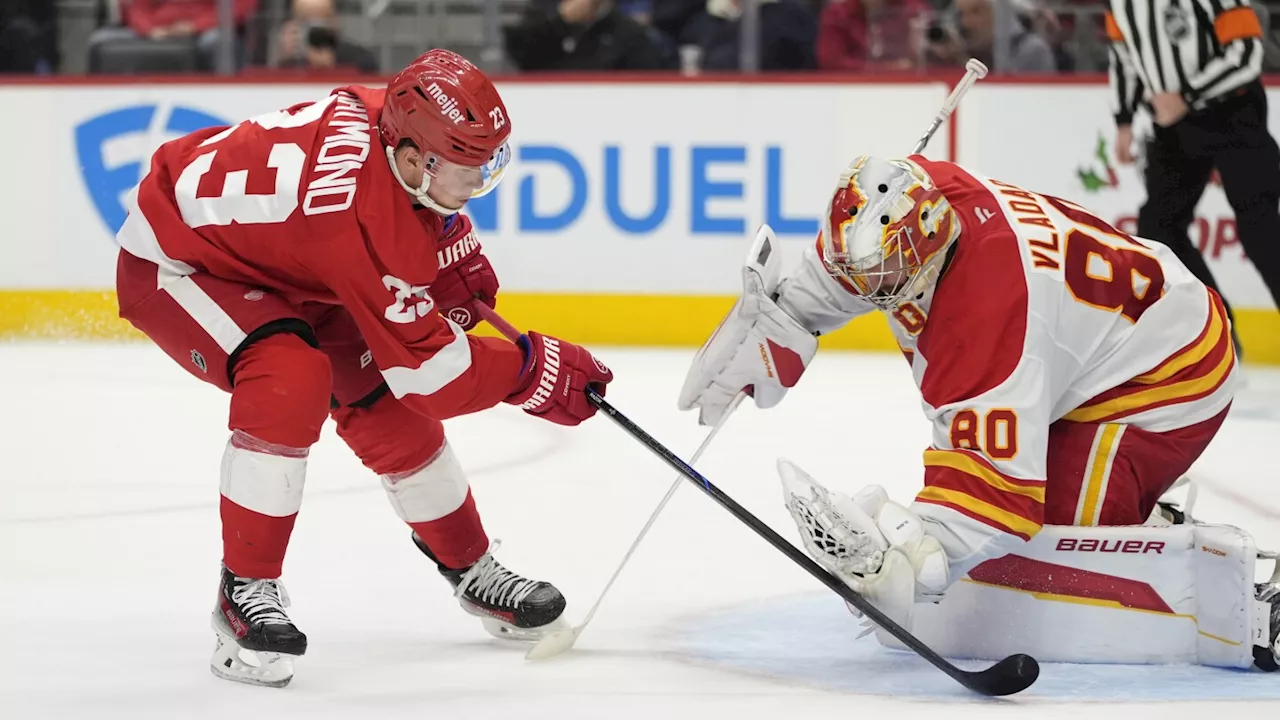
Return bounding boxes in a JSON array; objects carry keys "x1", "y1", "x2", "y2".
[{"x1": 929, "y1": 0, "x2": 1057, "y2": 73}]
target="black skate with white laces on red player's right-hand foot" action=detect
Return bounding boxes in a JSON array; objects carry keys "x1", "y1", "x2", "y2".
[{"x1": 412, "y1": 533, "x2": 564, "y2": 641}]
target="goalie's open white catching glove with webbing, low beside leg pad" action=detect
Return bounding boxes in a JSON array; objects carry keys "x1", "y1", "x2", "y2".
[{"x1": 778, "y1": 460, "x2": 951, "y2": 637}]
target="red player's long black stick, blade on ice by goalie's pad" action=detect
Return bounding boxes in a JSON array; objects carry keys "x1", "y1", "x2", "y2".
[{"x1": 475, "y1": 302, "x2": 1039, "y2": 696}]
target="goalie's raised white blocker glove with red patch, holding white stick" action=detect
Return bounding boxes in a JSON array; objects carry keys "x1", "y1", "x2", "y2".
[{"x1": 680, "y1": 225, "x2": 818, "y2": 425}]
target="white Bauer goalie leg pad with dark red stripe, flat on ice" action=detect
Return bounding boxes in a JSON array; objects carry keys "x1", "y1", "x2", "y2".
[{"x1": 877, "y1": 524, "x2": 1265, "y2": 667}]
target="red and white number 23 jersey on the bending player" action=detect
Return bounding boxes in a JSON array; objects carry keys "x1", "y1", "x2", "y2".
[{"x1": 118, "y1": 87, "x2": 524, "y2": 418}]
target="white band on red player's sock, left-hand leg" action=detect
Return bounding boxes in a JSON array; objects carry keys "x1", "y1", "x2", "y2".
[{"x1": 219, "y1": 430, "x2": 307, "y2": 518}]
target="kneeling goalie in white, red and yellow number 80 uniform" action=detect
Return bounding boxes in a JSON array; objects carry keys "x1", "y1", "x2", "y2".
[{"x1": 680, "y1": 155, "x2": 1280, "y2": 670}]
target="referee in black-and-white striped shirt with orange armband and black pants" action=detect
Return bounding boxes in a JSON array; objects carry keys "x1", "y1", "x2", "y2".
[{"x1": 1106, "y1": 0, "x2": 1280, "y2": 350}]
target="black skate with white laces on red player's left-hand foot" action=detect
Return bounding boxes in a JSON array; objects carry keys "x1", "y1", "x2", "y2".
[{"x1": 209, "y1": 566, "x2": 307, "y2": 688}]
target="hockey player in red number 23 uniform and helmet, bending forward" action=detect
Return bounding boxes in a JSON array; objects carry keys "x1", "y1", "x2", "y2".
[{"x1": 116, "y1": 50, "x2": 612, "y2": 685}]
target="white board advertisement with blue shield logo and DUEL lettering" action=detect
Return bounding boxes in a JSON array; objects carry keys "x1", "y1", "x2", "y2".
[{"x1": 0, "y1": 82, "x2": 948, "y2": 295}]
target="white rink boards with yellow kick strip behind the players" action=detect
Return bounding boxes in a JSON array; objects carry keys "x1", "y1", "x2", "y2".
[{"x1": 0, "y1": 78, "x2": 1280, "y2": 364}]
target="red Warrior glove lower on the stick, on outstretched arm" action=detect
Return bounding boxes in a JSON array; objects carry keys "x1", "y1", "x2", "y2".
[{"x1": 507, "y1": 332, "x2": 613, "y2": 425}]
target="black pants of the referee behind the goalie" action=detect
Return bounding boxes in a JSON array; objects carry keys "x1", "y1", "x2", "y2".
[{"x1": 1138, "y1": 82, "x2": 1280, "y2": 322}]
